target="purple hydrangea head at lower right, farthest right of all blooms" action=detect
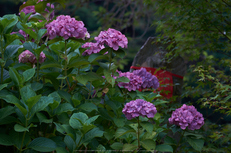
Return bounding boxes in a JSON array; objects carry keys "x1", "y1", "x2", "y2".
[{"x1": 168, "y1": 104, "x2": 204, "y2": 130}]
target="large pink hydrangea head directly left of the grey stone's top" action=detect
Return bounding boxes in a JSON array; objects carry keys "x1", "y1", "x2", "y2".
[{"x1": 95, "y1": 28, "x2": 128, "y2": 50}]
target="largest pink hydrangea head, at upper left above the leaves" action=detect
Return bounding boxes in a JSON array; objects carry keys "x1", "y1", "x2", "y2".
[{"x1": 46, "y1": 15, "x2": 88, "y2": 40}]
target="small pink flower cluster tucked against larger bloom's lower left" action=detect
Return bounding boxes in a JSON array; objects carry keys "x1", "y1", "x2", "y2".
[{"x1": 82, "y1": 42, "x2": 105, "y2": 56}]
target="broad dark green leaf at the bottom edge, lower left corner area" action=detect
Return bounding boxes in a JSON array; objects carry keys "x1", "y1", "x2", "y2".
[{"x1": 28, "y1": 137, "x2": 57, "y2": 152}]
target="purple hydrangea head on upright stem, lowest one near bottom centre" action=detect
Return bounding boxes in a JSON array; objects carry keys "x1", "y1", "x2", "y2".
[{"x1": 122, "y1": 99, "x2": 157, "y2": 120}]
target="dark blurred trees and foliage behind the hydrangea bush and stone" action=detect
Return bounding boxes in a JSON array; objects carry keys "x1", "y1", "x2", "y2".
[{"x1": 0, "y1": 0, "x2": 231, "y2": 151}]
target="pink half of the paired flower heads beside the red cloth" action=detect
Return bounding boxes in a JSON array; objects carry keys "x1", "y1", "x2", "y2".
[{"x1": 118, "y1": 71, "x2": 143, "y2": 91}]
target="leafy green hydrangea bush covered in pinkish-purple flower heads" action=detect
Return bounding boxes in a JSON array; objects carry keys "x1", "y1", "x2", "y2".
[{"x1": 0, "y1": 0, "x2": 204, "y2": 153}]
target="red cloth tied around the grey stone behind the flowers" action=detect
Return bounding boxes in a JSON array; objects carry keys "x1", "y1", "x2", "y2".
[{"x1": 131, "y1": 66, "x2": 183, "y2": 99}]
